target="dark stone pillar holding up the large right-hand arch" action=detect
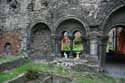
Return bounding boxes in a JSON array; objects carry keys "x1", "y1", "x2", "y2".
[{"x1": 99, "y1": 36, "x2": 108, "y2": 71}]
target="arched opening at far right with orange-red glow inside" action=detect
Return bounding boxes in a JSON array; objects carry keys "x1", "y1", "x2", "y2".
[{"x1": 106, "y1": 26, "x2": 125, "y2": 63}]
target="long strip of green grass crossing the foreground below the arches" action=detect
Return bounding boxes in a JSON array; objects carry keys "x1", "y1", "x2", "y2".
[{"x1": 0, "y1": 63, "x2": 125, "y2": 83}]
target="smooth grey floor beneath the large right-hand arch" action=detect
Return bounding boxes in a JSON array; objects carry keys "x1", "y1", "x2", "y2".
[{"x1": 104, "y1": 63, "x2": 125, "y2": 78}]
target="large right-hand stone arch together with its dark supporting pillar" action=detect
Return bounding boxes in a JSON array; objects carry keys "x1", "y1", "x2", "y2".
[{"x1": 100, "y1": 4, "x2": 125, "y2": 67}]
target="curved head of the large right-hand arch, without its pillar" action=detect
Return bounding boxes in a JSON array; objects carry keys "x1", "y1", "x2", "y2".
[{"x1": 101, "y1": 4, "x2": 125, "y2": 35}]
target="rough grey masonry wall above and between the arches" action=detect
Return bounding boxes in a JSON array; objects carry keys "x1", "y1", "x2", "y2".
[{"x1": 0, "y1": 0, "x2": 125, "y2": 56}]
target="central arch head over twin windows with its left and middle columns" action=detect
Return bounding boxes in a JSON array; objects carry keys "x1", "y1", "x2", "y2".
[{"x1": 55, "y1": 17, "x2": 89, "y2": 56}]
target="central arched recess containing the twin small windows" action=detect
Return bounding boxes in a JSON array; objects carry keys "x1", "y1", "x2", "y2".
[{"x1": 56, "y1": 19, "x2": 89, "y2": 58}]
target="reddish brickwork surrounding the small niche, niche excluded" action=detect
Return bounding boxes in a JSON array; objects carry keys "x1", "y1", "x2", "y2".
[{"x1": 0, "y1": 32, "x2": 19, "y2": 56}]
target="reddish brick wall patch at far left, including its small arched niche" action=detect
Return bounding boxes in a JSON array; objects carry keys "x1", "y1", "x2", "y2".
[{"x1": 0, "y1": 32, "x2": 19, "y2": 56}]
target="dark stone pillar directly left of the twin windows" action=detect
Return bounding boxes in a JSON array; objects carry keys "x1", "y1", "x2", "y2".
[{"x1": 55, "y1": 36, "x2": 61, "y2": 57}]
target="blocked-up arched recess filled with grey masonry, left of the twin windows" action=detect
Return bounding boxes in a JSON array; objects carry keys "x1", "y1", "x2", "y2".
[{"x1": 30, "y1": 23, "x2": 51, "y2": 56}]
